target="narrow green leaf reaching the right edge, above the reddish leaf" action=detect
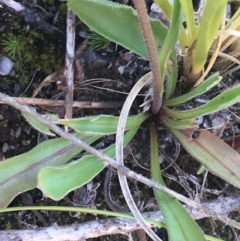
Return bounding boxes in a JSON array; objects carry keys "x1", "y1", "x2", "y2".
[{"x1": 160, "y1": 85, "x2": 240, "y2": 119}]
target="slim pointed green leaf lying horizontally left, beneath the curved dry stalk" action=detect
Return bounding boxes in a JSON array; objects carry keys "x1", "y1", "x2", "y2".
[{"x1": 57, "y1": 113, "x2": 149, "y2": 135}]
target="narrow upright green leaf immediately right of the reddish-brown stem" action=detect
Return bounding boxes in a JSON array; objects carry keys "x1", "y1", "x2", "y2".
[{"x1": 159, "y1": 0, "x2": 181, "y2": 99}]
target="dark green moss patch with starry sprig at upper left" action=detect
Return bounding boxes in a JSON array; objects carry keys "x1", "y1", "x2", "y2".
[{"x1": 0, "y1": 20, "x2": 64, "y2": 84}]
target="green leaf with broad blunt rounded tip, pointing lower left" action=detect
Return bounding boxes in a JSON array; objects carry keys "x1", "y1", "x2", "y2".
[{"x1": 38, "y1": 127, "x2": 138, "y2": 200}]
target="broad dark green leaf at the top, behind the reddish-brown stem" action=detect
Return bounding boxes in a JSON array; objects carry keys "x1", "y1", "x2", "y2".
[{"x1": 68, "y1": 0, "x2": 167, "y2": 58}]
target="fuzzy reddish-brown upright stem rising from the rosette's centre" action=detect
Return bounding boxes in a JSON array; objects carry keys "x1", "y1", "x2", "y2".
[{"x1": 134, "y1": 0, "x2": 163, "y2": 114}]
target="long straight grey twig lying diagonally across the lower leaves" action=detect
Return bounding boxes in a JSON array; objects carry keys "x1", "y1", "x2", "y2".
[{"x1": 0, "y1": 93, "x2": 240, "y2": 229}]
